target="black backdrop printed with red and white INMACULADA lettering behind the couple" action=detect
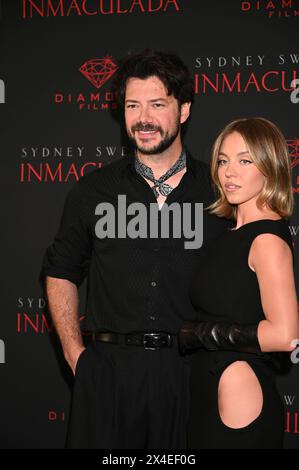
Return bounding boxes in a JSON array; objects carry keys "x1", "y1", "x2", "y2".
[{"x1": 0, "y1": 0, "x2": 299, "y2": 448}]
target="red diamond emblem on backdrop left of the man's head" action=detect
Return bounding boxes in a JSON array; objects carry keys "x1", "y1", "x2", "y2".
[{"x1": 79, "y1": 57, "x2": 117, "y2": 88}]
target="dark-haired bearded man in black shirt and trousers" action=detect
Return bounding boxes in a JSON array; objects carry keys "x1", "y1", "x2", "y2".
[{"x1": 42, "y1": 50, "x2": 225, "y2": 449}]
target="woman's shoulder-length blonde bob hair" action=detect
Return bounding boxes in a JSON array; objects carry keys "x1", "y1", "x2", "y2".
[{"x1": 208, "y1": 118, "x2": 294, "y2": 219}]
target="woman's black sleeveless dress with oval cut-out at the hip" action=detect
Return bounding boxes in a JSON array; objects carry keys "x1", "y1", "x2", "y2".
[{"x1": 188, "y1": 219, "x2": 292, "y2": 449}]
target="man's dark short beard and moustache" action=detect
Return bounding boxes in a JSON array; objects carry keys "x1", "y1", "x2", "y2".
[{"x1": 128, "y1": 117, "x2": 181, "y2": 155}]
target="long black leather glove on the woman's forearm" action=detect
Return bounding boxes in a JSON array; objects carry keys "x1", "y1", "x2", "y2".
[{"x1": 178, "y1": 321, "x2": 262, "y2": 354}]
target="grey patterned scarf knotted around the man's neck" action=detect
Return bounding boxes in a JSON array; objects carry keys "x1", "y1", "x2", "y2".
[{"x1": 135, "y1": 150, "x2": 186, "y2": 199}]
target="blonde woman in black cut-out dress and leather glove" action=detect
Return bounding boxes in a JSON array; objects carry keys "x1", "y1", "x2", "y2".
[{"x1": 179, "y1": 118, "x2": 299, "y2": 449}]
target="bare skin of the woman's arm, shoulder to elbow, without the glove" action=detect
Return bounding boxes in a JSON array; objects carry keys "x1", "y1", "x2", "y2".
[{"x1": 248, "y1": 233, "x2": 299, "y2": 352}]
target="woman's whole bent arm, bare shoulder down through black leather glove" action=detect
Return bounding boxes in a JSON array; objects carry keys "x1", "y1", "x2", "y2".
[{"x1": 178, "y1": 234, "x2": 299, "y2": 354}]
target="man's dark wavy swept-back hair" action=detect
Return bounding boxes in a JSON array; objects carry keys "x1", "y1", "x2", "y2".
[{"x1": 112, "y1": 49, "x2": 194, "y2": 106}]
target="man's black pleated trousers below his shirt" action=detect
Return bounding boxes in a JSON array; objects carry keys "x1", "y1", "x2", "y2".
[{"x1": 67, "y1": 342, "x2": 190, "y2": 449}]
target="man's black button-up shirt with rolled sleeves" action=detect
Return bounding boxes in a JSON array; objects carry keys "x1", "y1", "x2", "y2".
[{"x1": 41, "y1": 152, "x2": 227, "y2": 333}]
